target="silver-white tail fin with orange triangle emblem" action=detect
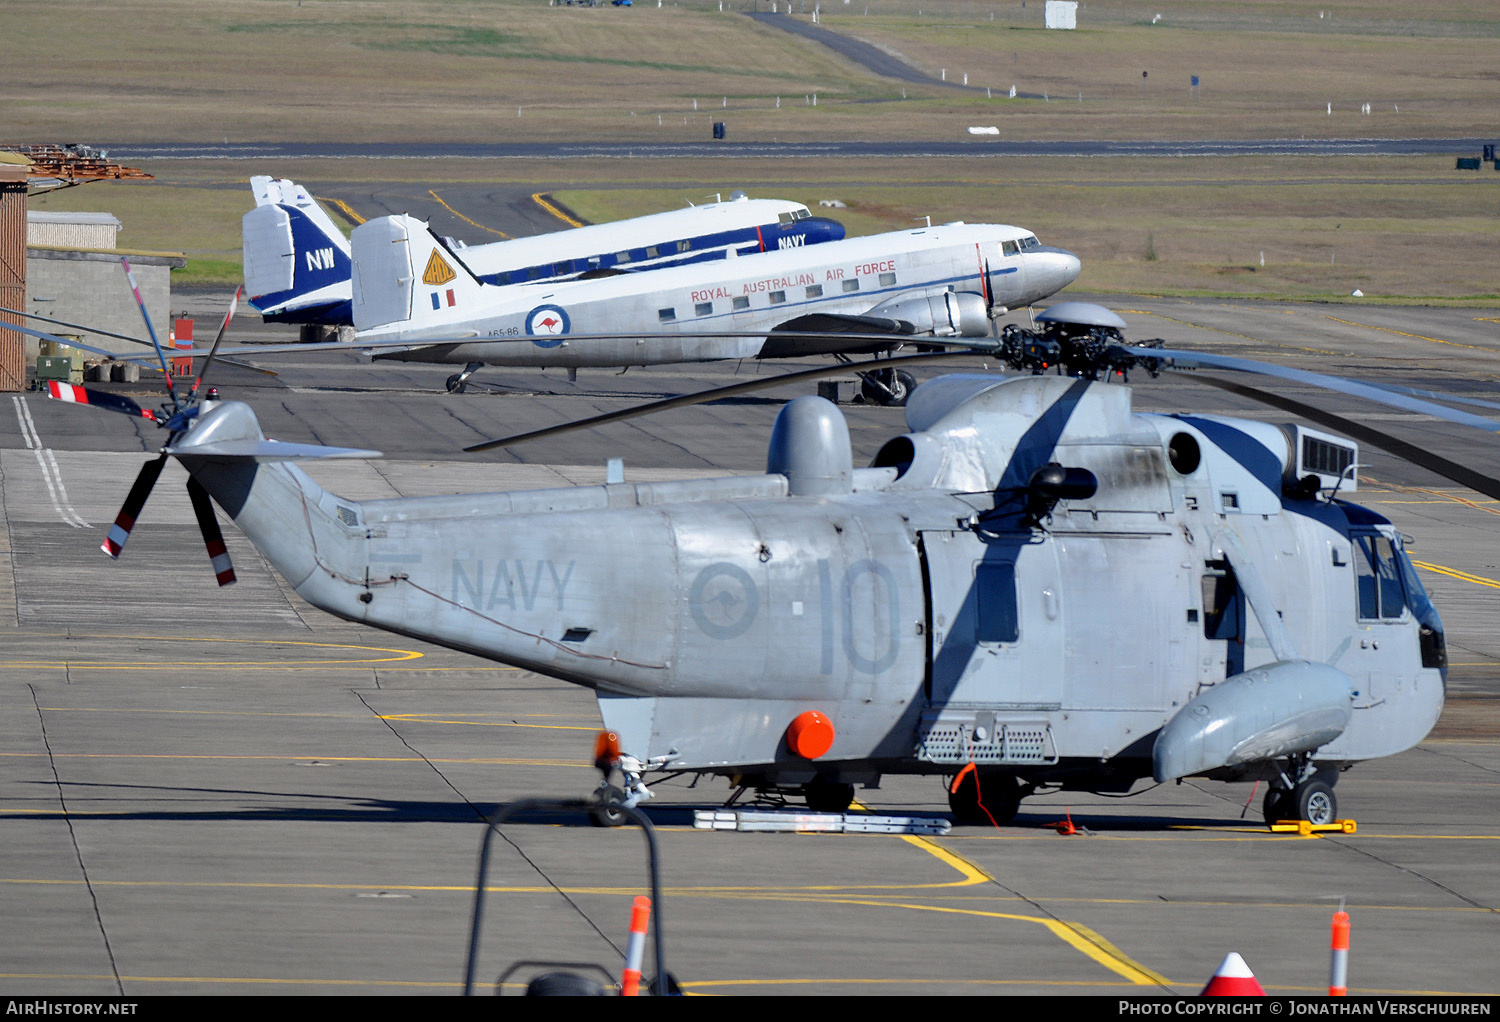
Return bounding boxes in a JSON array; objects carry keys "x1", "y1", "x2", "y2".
[{"x1": 351, "y1": 216, "x2": 485, "y2": 330}]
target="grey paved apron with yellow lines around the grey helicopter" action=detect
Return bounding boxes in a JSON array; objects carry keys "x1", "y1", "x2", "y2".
[{"x1": 0, "y1": 296, "x2": 1500, "y2": 996}]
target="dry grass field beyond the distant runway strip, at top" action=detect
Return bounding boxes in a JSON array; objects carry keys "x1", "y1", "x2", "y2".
[{"x1": 0, "y1": 0, "x2": 1500, "y2": 143}]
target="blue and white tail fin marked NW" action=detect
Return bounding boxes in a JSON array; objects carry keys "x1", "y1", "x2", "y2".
[{"x1": 240, "y1": 176, "x2": 351, "y2": 323}]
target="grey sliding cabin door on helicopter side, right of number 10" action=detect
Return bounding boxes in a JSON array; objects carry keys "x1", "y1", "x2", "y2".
[{"x1": 918, "y1": 530, "x2": 1064, "y2": 764}]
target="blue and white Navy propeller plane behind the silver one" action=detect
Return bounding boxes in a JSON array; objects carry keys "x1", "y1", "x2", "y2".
[{"x1": 240, "y1": 176, "x2": 845, "y2": 339}]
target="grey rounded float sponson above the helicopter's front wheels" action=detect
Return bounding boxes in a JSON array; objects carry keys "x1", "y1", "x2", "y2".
[{"x1": 1152, "y1": 660, "x2": 1355, "y2": 782}]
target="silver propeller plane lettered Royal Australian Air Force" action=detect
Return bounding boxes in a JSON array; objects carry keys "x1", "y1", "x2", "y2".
[{"x1": 353, "y1": 216, "x2": 1080, "y2": 404}]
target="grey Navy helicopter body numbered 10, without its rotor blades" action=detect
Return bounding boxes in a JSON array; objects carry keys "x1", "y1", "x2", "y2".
[{"x1": 168, "y1": 375, "x2": 1446, "y2": 822}]
